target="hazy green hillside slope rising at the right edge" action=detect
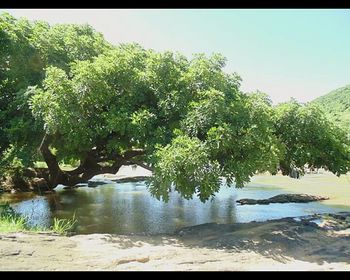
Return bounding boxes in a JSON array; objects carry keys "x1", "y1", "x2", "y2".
[{"x1": 311, "y1": 85, "x2": 350, "y2": 133}]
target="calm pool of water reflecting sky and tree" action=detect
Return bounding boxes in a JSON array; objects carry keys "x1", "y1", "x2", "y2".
[{"x1": 0, "y1": 178, "x2": 350, "y2": 234}]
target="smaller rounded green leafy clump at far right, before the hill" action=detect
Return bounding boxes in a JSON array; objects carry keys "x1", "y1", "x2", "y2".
[{"x1": 275, "y1": 100, "x2": 350, "y2": 176}]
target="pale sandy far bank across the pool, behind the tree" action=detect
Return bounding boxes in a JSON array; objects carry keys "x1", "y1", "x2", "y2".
[{"x1": 0, "y1": 166, "x2": 350, "y2": 206}]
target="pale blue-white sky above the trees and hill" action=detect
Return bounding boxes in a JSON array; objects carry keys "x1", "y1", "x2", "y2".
[{"x1": 0, "y1": 9, "x2": 350, "y2": 104}]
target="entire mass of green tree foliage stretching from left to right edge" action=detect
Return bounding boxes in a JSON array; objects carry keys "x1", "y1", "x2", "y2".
[{"x1": 0, "y1": 14, "x2": 349, "y2": 201}]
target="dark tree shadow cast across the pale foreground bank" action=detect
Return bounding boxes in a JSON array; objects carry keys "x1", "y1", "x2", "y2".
[{"x1": 105, "y1": 215, "x2": 350, "y2": 265}]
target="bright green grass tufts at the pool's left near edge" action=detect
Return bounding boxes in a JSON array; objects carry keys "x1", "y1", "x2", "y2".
[{"x1": 0, "y1": 203, "x2": 77, "y2": 235}]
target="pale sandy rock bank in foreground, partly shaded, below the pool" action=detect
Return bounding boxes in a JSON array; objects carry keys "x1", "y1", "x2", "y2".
[{"x1": 0, "y1": 213, "x2": 350, "y2": 270}]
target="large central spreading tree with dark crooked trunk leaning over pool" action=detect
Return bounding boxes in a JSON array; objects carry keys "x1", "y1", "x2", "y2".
[{"x1": 31, "y1": 45, "x2": 279, "y2": 200}]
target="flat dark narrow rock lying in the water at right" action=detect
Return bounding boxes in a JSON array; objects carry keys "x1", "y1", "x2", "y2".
[{"x1": 237, "y1": 194, "x2": 329, "y2": 205}]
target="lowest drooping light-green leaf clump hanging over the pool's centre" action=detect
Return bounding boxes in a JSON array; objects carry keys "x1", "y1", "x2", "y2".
[{"x1": 149, "y1": 135, "x2": 221, "y2": 201}]
